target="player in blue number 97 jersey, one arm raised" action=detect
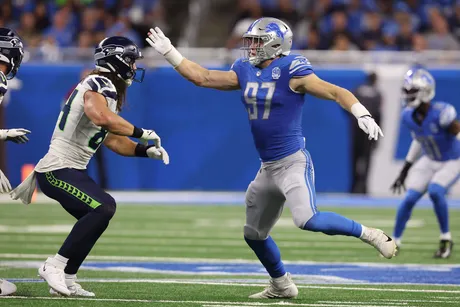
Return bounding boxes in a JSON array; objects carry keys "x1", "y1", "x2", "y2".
[{"x1": 146, "y1": 18, "x2": 396, "y2": 298}]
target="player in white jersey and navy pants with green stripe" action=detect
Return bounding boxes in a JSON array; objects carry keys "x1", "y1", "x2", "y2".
[{"x1": 11, "y1": 36, "x2": 169, "y2": 296}]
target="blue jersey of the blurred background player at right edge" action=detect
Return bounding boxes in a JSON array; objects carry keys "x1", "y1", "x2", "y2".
[{"x1": 402, "y1": 102, "x2": 460, "y2": 161}]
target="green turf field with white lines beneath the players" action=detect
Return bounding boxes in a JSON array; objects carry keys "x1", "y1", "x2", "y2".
[{"x1": 0, "y1": 203, "x2": 460, "y2": 307}]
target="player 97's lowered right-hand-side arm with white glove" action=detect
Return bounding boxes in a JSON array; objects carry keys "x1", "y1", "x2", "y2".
[{"x1": 289, "y1": 73, "x2": 383, "y2": 140}]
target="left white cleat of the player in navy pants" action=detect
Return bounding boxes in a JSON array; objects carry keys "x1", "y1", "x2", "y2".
[{"x1": 38, "y1": 257, "x2": 70, "y2": 296}]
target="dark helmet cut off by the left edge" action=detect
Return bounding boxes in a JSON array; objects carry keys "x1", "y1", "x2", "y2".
[{"x1": 0, "y1": 28, "x2": 24, "y2": 80}]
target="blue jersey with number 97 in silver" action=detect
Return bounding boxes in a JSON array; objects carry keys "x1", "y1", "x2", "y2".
[{"x1": 231, "y1": 55, "x2": 313, "y2": 161}]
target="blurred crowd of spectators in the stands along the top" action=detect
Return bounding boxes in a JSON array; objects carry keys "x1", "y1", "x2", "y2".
[{"x1": 0, "y1": 0, "x2": 460, "y2": 51}]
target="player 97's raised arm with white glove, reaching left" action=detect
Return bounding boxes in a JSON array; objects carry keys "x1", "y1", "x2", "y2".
[{"x1": 146, "y1": 27, "x2": 240, "y2": 90}]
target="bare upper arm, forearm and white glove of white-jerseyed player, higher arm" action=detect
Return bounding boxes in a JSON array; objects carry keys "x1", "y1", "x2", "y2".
[{"x1": 84, "y1": 91, "x2": 161, "y2": 148}]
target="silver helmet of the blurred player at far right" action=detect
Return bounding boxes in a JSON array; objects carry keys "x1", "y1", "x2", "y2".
[{"x1": 402, "y1": 68, "x2": 436, "y2": 108}]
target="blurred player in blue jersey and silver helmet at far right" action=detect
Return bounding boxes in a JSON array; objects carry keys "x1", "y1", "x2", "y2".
[{"x1": 392, "y1": 68, "x2": 460, "y2": 258}]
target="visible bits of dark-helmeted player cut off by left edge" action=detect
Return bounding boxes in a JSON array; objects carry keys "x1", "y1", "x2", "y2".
[{"x1": 0, "y1": 28, "x2": 30, "y2": 296}]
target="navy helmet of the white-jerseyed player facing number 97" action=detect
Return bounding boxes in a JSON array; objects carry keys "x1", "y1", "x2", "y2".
[{"x1": 94, "y1": 36, "x2": 145, "y2": 85}]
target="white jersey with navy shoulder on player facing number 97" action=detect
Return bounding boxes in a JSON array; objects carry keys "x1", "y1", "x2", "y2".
[{"x1": 35, "y1": 75, "x2": 117, "y2": 172}]
